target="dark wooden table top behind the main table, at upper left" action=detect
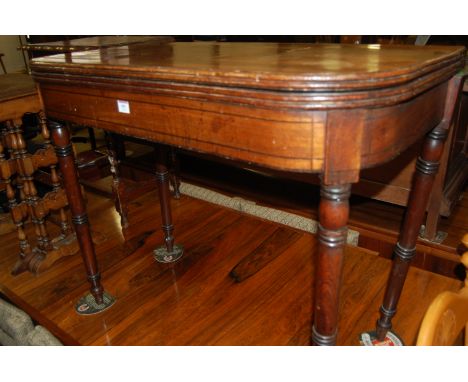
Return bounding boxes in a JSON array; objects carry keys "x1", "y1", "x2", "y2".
[{"x1": 21, "y1": 36, "x2": 173, "y2": 52}]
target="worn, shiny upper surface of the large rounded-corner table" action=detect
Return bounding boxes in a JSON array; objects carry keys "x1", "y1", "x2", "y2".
[{"x1": 32, "y1": 41, "x2": 465, "y2": 91}]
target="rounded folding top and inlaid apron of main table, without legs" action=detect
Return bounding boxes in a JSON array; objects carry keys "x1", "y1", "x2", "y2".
[{"x1": 31, "y1": 41, "x2": 465, "y2": 178}]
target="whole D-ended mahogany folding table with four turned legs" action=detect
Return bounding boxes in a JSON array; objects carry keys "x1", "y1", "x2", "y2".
[{"x1": 31, "y1": 42, "x2": 465, "y2": 345}]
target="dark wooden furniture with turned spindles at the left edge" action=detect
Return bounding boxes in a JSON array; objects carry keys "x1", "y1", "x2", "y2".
[{"x1": 0, "y1": 74, "x2": 78, "y2": 274}]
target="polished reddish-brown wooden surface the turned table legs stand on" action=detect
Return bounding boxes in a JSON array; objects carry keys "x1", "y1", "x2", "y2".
[{"x1": 0, "y1": 184, "x2": 460, "y2": 345}]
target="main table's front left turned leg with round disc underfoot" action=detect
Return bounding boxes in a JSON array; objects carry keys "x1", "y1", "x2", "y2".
[{"x1": 49, "y1": 122, "x2": 115, "y2": 314}]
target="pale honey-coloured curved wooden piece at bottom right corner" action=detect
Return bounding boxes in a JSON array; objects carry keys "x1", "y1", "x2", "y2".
[{"x1": 416, "y1": 234, "x2": 468, "y2": 346}]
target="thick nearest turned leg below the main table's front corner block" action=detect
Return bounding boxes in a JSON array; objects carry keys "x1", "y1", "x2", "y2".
[{"x1": 312, "y1": 183, "x2": 351, "y2": 345}]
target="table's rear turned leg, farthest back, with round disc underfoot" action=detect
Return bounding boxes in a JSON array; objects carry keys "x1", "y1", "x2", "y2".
[{"x1": 154, "y1": 146, "x2": 183, "y2": 263}]
